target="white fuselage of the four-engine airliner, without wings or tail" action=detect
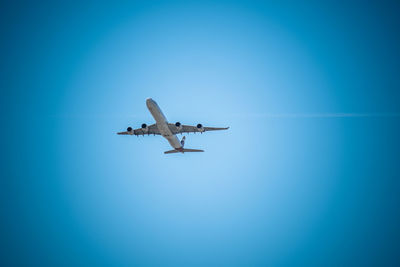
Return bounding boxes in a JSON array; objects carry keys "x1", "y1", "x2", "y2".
[{"x1": 146, "y1": 98, "x2": 182, "y2": 149}]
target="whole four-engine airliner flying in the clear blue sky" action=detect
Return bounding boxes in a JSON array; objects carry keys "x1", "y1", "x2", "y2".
[{"x1": 117, "y1": 98, "x2": 229, "y2": 154}]
